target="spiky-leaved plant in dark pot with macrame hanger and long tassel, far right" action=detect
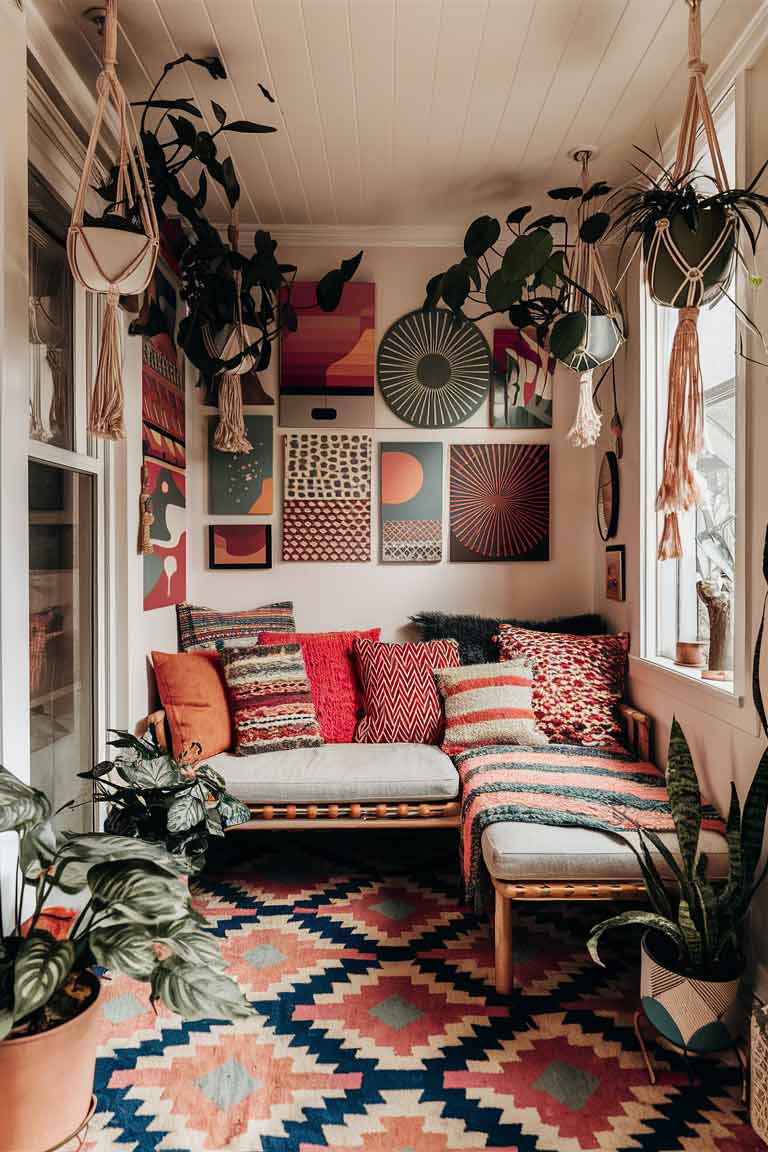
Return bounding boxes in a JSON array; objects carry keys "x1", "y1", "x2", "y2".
[{"x1": 615, "y1": 0, "x2": 768, "y2": 560}]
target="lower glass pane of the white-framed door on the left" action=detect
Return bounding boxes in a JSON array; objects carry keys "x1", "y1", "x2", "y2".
[{"x1": 29, "y1": 460, "x2": 93, "y2": 832}]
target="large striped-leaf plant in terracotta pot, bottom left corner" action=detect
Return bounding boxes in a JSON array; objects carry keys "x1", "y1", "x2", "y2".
[{"x1": 0, "y1": 767, "x2": 251, "y2": 1152}]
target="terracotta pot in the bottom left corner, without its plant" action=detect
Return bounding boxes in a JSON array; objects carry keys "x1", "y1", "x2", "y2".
[{"x1": 0, "y1": 972, "x2": 100, "y2": 1152}]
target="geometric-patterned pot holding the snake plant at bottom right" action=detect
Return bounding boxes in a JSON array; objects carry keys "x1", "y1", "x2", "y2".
[{"x1": 640, "y1": 931, "x2": 744, "y2": 1052}]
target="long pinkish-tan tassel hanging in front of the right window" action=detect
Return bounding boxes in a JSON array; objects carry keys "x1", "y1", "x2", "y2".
[{"x1": 656, "y1": 308, "x2": 704, "y2": 560}]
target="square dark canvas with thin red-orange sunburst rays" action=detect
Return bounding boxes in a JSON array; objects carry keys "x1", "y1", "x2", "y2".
[{"x1": 450, "y1": 444, "x2": 549, "y2": 562}]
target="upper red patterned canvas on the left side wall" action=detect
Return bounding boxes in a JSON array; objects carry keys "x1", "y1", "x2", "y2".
[{"x1": 142, "y1": 268, "x2": 187, "y2": 468}]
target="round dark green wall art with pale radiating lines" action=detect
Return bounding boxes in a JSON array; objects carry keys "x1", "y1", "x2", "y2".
[{"x1": 377, "y1": 308, "x2": 491, "y2": 429}]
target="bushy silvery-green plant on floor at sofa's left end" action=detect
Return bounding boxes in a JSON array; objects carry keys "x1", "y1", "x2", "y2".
[{"x1": 78, "y1": 729, "x2": 251, "y2": 872}]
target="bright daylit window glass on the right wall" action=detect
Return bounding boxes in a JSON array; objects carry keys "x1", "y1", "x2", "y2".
[{"x1": 642, "y1": 93, "x2": 739, "y2": 691}]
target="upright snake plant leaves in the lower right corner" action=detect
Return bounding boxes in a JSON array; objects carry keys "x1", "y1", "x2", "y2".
[{"x1": 587, "y1": 530, "x2": 768, "y2": 979}]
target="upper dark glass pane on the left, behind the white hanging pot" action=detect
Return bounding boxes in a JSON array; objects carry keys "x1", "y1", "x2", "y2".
[{"x1": 29, "y1": 174, "x2": 74, "y2": 448}]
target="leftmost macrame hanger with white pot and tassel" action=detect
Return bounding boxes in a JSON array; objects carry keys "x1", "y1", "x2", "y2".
[{"x1": 67, "y1": 0, "x2": 159, "y2": 440}]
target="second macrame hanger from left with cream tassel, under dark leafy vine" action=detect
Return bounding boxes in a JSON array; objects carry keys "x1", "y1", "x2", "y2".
[{"x1": 204, "y1": 204, "x2": 254, "y2": 452}]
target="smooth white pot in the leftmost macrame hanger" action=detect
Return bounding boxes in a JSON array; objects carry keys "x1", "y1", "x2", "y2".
[{"x1": 67, "y1": 225, "x2": 158, "y2": 296}]
